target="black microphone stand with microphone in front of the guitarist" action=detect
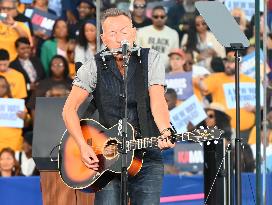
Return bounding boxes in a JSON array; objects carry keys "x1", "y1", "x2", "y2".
[{"x1": 121, "y1": 52, "x2": 129, "y2": 205}]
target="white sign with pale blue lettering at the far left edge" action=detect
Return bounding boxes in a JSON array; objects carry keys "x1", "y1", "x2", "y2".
[{"x1": 0, "y1": 98, "x2": 25, "y2": 128}]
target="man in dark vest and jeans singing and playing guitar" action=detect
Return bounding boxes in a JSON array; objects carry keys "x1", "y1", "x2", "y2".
[{"x1": 63, "y1": 8, "x2": 175, "y2": 205}]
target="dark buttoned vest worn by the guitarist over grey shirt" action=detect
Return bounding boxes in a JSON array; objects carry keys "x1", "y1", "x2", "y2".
[{"x1": 93, "y1": 49, "x2": 159, "y2": 137}]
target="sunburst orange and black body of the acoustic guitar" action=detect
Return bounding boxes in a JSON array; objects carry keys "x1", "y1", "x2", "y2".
[{"x1": 58, "y1": 119, "x2": 142, "y2": 192}]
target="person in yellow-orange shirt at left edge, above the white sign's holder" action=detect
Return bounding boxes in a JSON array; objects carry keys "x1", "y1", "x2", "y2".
[{"x1": 0, "y1": 49, "x2": 27, "y2": 98}]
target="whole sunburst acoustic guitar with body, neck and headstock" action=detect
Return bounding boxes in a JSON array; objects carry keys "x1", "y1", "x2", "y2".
[{"x1": 58, "y1": 119, "x2": 222, "y2": 192}]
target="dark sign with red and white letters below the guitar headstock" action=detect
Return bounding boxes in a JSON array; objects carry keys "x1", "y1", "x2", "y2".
[{"x1": 174, "y1": 142, "x2": 204, "y2": 172}]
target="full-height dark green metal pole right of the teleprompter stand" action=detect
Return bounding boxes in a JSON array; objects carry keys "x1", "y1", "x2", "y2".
[{"x1": 255, "y1": 0, "x2": 262, "y2": 205}]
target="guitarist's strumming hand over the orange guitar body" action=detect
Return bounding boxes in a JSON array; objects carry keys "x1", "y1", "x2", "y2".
[{"x1": 80, "y1": 143, "x2": 99, "y2": 171}]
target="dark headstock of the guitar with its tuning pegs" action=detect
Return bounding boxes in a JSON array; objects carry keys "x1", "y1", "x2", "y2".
[{"x1": 177, "y1": 127, "x2": 224, "y2": 143}]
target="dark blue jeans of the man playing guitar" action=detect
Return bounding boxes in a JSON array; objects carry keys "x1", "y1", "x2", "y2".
[{"x1": 94, "y1": 160, "x2": 163, "y2": 205}]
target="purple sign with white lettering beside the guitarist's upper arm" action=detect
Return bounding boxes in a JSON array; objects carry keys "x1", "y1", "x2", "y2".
[{"x1": 165, "y1": 72, "x2": 194, "y2": 100}]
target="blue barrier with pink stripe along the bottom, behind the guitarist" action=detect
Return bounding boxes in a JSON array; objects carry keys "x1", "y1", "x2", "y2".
[{"x1": 0, "y1": 173, "x2": 272, "y2": 205}]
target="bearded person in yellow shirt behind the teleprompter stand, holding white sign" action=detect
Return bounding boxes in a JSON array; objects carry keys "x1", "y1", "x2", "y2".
[{"x1": 198, "y1": 52, "x2": 255, "y2": 142}]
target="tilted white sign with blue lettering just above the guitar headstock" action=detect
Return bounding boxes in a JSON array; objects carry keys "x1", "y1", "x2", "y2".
[{"x1": 170, "y1": 95, "x2": 207, "y2": 133}]
